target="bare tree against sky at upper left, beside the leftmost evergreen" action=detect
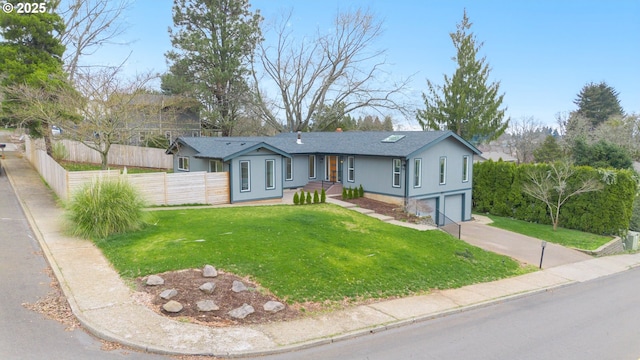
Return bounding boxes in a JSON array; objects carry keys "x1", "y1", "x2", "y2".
[{"x1": 54, "y1": 0, "x2": 133, "y2": 81}]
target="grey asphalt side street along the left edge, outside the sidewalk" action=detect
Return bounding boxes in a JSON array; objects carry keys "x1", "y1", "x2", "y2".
[{"x1": 0, "y1": 161, "x2": 167, "y2": 360}]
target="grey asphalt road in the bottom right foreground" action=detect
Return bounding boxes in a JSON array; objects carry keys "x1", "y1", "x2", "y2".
[{"x1": 254, "y1": 268, "x2": 640, "y2": 360}]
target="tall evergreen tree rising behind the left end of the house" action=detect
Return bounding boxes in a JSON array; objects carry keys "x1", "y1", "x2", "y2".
[{"x1": 162, "y1": 0, "x2": 262, "y2": 136}]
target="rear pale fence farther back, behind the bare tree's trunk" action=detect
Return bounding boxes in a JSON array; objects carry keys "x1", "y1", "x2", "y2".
[{"x1": 60, "y1": 140, "x2": 173, "y2": 169}]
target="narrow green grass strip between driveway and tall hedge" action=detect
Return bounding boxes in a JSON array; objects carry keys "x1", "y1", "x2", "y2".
[{"x1": 489, "y1": 215, "x2": 612, "y2": 250}]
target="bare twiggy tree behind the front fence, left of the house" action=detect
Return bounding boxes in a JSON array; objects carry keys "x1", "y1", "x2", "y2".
[{"x1": 63, "y1": 68, "x2": 160, "y2": 169}]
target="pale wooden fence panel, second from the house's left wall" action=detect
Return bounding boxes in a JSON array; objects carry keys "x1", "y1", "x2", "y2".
[{"x1": 166, "y1": 171, "x2": 207, "y2": 205}]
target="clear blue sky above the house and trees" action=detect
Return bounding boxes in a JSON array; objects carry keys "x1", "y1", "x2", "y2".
[{"x1": 87, "y1": 0, "x2": 640, "y2": 128}]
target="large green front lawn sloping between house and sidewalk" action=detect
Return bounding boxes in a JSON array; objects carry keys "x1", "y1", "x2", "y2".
[{"x1": 96, "y1": 204, "x2": 530, "y2": 302}]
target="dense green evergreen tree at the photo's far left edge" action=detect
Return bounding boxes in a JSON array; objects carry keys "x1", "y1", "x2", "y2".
[{"x1": 0, "y1": 1, "x2": 69, "y2": 155}]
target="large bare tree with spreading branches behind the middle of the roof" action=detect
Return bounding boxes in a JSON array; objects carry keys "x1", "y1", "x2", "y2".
[{"x1": 253, "y1": 10, "x2": 408, "y2": 131}]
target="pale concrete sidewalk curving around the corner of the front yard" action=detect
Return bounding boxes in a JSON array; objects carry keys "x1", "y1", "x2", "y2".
[{"x1": 2, "y1": 154, "x2": 640, "y2": 357}]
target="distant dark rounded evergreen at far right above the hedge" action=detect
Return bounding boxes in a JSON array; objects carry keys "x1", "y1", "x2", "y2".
[{"x1": 573, "y1": 81, "x2": 624, "y2": 128}]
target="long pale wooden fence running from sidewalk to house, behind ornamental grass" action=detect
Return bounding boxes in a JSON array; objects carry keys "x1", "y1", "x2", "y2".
[{"x1": 25, "y1": 138, "x2": 230, "y2": 205}]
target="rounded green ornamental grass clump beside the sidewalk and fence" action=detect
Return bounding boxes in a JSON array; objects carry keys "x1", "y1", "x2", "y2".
[{"x1": 67, "y1": 180, "x2": 146, "y2": 239}]
